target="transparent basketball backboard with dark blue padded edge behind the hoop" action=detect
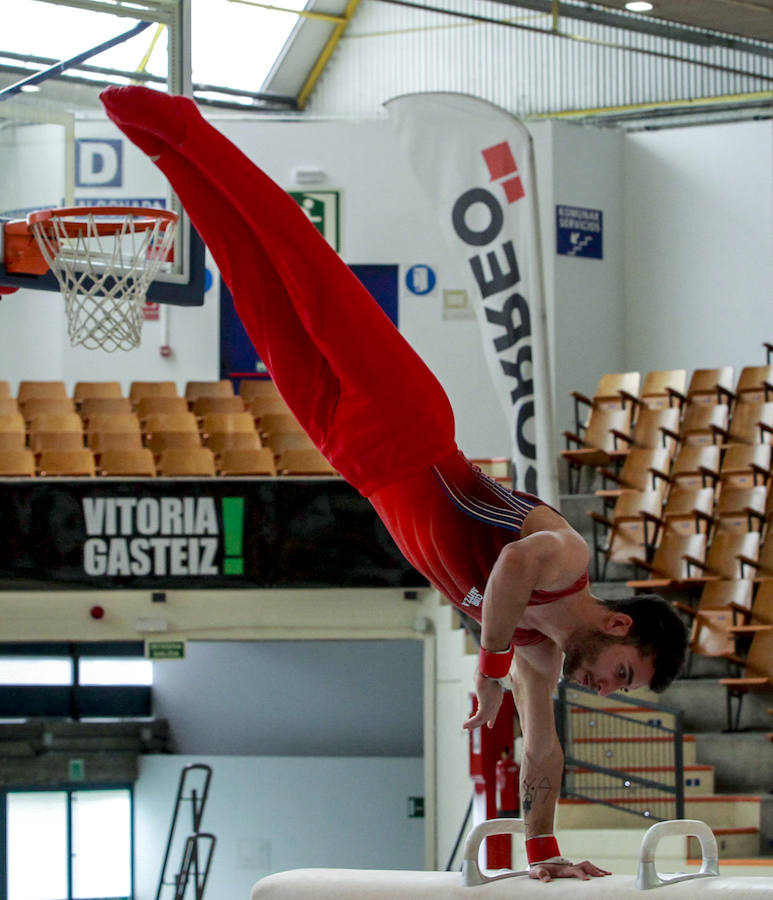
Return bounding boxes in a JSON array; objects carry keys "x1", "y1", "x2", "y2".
[{"x1": 0, "y1": 0, "x2": 204, "y2": 306}]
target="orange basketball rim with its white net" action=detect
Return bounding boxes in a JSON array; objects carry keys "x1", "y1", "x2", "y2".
[{"x1": 27, "y1": 206, "x2": 179, "y2": 353}]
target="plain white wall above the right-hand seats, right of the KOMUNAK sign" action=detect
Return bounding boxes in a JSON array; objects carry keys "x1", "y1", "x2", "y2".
[{"x1": 624, "y1": 122, "x2": 773, "y2": 376}]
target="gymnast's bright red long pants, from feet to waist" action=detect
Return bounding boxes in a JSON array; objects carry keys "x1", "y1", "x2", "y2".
[{"x1": 102, "y1": 87, "x2": 455, "y2": 497}]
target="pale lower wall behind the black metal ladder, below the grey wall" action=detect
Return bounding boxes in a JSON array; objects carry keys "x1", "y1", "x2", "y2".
[{"x1": 134, "y1": 756, "x2": 424, "y2": 900}]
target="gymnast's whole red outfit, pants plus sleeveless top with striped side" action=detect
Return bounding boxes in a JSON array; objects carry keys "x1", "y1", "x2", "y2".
[{"x1": 102, "y1": 87, "x2": 587, "y2": 643}]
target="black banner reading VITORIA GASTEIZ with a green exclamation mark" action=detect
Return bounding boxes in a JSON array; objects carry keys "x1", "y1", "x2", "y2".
[{"x1": 0, "y1": 479, "x2": 427, "y2": 590}]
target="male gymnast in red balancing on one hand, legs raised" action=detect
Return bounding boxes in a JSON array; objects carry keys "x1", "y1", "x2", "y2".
[{"x1": 101, "y1": 86, "x2": 686, "y2": 881}]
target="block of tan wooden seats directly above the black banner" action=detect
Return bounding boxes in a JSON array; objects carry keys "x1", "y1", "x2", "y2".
[{"x1": 0, "y1": 381, "x2": 337, "y2": 477}]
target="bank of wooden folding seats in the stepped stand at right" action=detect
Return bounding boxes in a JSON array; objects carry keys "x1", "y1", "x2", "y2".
[{"x1": 563, "y1": 358, "x2": 773, "y2": 729}]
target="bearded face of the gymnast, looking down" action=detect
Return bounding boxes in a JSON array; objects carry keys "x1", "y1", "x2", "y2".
[{"x1": 563, "y1": 628, "x2": 655, "y2": 697}]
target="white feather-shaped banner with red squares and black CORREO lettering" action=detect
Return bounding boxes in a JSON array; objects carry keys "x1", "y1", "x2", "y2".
[{"x1": 385, "y1": 93, "x2": 558, "y2": 505}]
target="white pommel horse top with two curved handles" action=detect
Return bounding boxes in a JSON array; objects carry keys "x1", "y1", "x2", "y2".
[{"x1": 251, "y1": 819, "x2": 773, "y2": 900}]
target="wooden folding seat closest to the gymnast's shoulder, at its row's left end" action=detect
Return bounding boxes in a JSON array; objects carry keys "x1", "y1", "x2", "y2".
[{"x1": 588, "y1": 490, "x2": 663, "y2": 580}]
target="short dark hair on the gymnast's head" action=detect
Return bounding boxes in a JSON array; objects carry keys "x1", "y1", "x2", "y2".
[{"x1": 601, "y1": 594, "x2": 687, "y2": 694}]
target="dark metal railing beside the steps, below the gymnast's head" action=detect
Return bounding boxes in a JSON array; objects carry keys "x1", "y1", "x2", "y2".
[{"x1": 555, "y1": 682, "x2": 685, "y2": 822}]
